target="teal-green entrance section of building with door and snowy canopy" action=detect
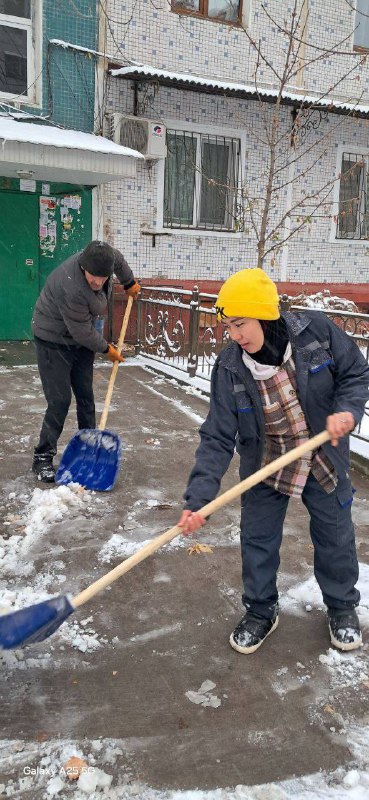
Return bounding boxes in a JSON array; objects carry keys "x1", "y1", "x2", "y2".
[{"x1": 0, "y1": 0, "x2": 138, "y2": 339}]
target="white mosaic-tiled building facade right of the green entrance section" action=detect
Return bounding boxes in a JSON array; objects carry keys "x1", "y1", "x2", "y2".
[{"x1": 104, "y1": 0, "x2": 369, "y2": 308}]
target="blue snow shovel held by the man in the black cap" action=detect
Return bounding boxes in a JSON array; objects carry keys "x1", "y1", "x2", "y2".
[{"x1": 55, "y1": 297, "x2": 133, "y2": 492}]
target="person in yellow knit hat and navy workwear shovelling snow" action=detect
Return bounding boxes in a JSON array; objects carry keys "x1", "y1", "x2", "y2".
[{"x1": 178, "y1": 268, "x2": 369, "y2": 654}]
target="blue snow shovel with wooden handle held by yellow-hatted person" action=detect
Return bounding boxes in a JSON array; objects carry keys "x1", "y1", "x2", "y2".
[{"x1": 0, "y1": 431, "x2": 330, "y2": 650}]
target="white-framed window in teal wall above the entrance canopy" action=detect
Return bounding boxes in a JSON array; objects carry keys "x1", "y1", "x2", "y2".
[{"x1": 0, "y1": 0, "x2": 39, "y2": 101}]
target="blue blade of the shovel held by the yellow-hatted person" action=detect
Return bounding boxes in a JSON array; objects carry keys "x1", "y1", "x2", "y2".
[{"x1": 0, "y1": 595, "x2": 74, "y2": 650}]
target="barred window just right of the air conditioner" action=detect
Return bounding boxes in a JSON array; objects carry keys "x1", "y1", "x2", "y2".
[{"x1": 163, "y1": 130, "x2": 240, "y2": 231}]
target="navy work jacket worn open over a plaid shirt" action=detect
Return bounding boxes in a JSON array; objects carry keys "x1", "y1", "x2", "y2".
[{"x1": 184, "y1": 311, "x2": 369, "y2": 511}]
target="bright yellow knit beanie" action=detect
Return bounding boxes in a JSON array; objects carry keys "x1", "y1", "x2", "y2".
[{"x1": 215, "y1": 267, "x2": 280, "y2": 319}]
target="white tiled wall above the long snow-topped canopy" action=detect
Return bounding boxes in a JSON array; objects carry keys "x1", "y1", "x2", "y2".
[{"x1": 107, "y1": 0, "x2": 369, "y2": 102}]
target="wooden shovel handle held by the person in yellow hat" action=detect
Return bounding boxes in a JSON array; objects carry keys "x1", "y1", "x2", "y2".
[{"x1": 72, "y1": 431, "x2": 330, "y2": 608}]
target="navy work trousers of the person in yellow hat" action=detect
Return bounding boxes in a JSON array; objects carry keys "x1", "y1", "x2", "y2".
[{"x1": 241, "y1": 473, "x2": 360, "y2": 619}]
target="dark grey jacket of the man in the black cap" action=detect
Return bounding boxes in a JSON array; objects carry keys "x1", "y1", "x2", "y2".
[{"x1": 32, "y1": 250, "x2": 135, "y2": 353}]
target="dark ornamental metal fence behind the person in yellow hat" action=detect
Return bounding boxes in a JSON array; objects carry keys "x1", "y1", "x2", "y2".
[{"x1": 136, "y1": 286, "x2": 369, "y2": 441}]
